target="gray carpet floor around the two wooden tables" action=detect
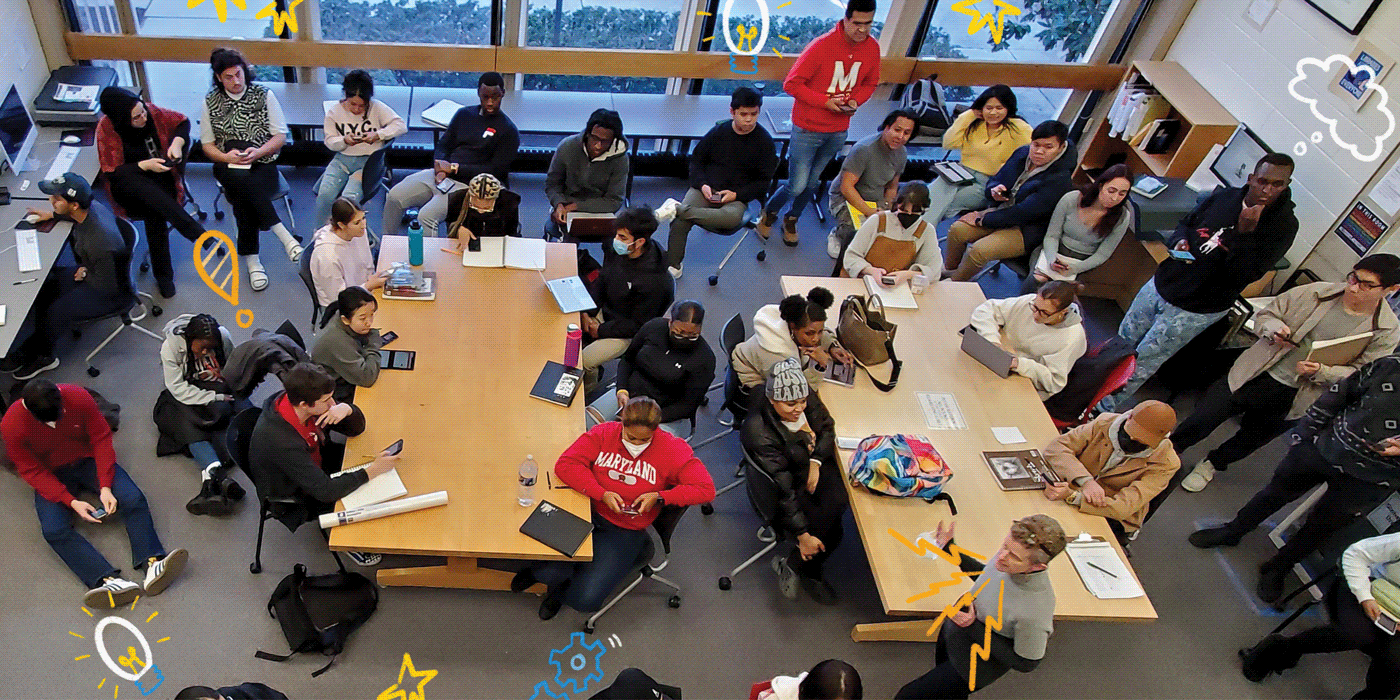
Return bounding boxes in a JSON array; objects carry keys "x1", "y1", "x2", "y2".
[{"x1": 0, "y1": 165, "x2": 1366, "y2": 700}]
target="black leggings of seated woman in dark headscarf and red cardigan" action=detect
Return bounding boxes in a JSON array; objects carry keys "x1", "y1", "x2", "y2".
[{"x1": 106, "y1": 167, "x2": 204, "y2": 280}]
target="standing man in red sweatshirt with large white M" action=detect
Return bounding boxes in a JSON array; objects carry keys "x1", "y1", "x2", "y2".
[{"x1": 757, "y1": 0, "x2": 879, "y2": 246}]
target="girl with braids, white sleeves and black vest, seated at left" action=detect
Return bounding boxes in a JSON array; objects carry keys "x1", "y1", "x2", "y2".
[{"x1": 154, "y1": 314, "x2": 246, "y2": 515}]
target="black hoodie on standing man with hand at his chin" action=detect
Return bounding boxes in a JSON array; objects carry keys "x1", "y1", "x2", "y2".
[{"x1": 1154, "y1": 188, "x2": 1298, "y2": 314}]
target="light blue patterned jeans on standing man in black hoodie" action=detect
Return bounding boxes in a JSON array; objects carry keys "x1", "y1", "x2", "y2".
[{"x1": 1099, "y1": 280, "x2": 1228, "y2": 412}]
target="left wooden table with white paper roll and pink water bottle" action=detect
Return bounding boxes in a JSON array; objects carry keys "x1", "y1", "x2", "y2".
[{"x1": 330, "y1": 235, "x2": 594, "y2": 591}]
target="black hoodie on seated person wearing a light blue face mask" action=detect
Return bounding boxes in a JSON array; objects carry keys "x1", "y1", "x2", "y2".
[{"x1": 588, "y1": 238, "x2": 676, "y2": 337}]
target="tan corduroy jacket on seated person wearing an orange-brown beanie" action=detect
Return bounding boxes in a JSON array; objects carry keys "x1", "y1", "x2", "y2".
[{"x1": 1044, "y1": 413, "x2": 1182, "y2": 532}]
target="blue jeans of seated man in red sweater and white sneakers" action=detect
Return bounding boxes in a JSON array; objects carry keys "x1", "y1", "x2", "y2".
[{"x1": 34, "y1": 458, "x2": 167, "y2": 588}]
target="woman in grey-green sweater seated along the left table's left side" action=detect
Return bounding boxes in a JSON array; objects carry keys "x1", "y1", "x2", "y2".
[{"x1": 311, "y1": 287, "x2": 384, "y2": 403}]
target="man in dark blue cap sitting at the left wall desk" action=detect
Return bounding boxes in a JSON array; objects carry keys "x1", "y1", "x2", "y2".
[{"x1": 0, "y1": 172, "x2": 132, "y2": 379}]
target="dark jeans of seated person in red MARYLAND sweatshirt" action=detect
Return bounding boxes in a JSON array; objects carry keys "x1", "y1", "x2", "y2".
[{"x1": 532, "y1": 512, "x2": 651, "y2": 613}]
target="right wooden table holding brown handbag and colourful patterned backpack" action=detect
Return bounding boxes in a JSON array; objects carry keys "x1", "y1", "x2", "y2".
[{"x1": 783, "y1": 276, "x2": 1156, "y2": 641}]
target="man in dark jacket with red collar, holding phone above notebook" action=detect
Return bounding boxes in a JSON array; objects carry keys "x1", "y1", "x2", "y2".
[{"x1": 248, "y1": 363, "x2": 399, "y2": 566}]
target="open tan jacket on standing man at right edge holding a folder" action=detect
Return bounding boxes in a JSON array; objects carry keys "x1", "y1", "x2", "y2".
[{"x1": 1228, "y1": 281, "x2": 1400, "y2": 420}]
